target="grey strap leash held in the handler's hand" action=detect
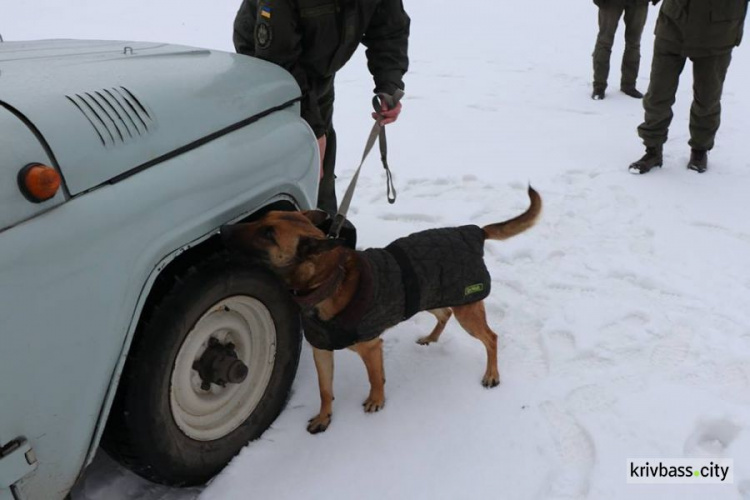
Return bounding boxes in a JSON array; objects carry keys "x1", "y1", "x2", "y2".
[{"x1": 328, "y1": 89, "x2": 404, "y2": 238}]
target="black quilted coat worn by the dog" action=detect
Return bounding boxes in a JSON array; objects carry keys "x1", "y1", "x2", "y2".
[{"x1": 302, "y1": 225, "x2": 490, "y2": 350}]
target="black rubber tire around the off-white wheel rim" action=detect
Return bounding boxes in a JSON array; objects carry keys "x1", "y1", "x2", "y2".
[{"x1": 102, "y1": 255, "x2": 301, "y2": 486}]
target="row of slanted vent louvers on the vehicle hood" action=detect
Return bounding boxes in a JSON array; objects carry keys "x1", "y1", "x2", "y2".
[{"x1": 65, "y1": 87, "x2": 154, "y2": 147}]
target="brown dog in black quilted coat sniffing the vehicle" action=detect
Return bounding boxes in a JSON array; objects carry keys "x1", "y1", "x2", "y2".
[{"x1": 221, "y1": 187, "x2": 542, "y2": 433}]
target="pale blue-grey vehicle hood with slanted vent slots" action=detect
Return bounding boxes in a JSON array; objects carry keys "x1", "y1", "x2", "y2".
[{"x1": 0, "y1": 40, "x2": 300, "y2": 196}]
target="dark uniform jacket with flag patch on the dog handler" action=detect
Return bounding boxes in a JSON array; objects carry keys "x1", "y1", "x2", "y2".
[{"x1": 234, "y1": 0, "x2": 410, "y2": 137}]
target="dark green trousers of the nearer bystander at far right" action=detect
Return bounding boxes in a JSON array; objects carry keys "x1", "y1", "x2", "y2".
[{"x1": 638, "y1": 38, "x2": 732, "y2": 151}]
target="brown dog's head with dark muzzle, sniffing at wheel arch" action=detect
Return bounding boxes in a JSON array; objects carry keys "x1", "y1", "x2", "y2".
[{"x1": 221, "y1": 210, "x2": 342, "y2": 274}]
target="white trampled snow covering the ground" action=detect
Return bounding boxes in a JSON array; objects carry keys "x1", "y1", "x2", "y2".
[{"x1": 7, "y1": 0, "x2": 750, "y2": 500}]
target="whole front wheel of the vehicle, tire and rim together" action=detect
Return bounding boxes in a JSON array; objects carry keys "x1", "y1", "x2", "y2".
[{"x1": 103, "y1": 256, "x2": 301, "y2": 486}]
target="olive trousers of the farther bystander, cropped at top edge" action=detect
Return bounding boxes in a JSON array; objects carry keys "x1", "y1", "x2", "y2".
[{"x1": 593, "y1": 1, "x2": 648, "y2": 90}]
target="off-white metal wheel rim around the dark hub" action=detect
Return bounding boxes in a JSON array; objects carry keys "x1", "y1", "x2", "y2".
[{"x1": 169, "y1": 295, "x2": 276, "y2": 441}]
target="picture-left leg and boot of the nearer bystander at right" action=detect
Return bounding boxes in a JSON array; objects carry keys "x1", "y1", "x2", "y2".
[{"x1": 629, "y1": 38, "x2": 685, "y2": 174}]
